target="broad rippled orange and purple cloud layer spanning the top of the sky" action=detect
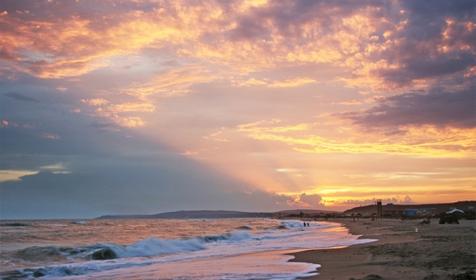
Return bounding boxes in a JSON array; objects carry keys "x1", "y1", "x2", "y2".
[{"x1": 0, "y1": 0, "x2": 476, "y2": 97}]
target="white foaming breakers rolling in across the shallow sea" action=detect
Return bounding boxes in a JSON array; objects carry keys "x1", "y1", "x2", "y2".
[{"x1": 0, "y1": 221, "x2": 334, "y2": 279}]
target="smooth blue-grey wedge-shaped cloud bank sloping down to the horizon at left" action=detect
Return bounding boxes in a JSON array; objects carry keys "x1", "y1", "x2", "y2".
[{"x1": 0, "y1": 93, "x2": 296, "y2": 218}]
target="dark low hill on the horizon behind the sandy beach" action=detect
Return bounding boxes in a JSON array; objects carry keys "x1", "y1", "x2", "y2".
[{"x1": 344, "y1": 201, "x2": 476, "y2": 216}]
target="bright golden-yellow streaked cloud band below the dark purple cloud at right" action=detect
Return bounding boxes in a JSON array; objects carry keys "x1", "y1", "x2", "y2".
[{"x1": 237, "y1": 118, "x2": 476, "y2": 158}]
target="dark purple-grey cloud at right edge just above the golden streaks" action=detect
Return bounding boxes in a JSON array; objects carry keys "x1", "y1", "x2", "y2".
[{"x1": 346, "y1": 86, "x2": 476, "y2": 128}]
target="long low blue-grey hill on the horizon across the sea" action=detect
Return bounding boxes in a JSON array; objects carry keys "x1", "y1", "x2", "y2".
[{"x1": 97, "y1": 210, "x2": 273, "y2": 219}]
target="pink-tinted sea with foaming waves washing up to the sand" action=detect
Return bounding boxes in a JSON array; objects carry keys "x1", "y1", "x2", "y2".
[{"x1": 0, "y1": 218, "x2": 373, "y2": 280}]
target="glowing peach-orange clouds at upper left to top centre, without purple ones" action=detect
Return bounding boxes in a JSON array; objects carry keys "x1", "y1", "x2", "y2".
[{"x1": 0, "y1": 1, "x2": 390, "y2": 87}]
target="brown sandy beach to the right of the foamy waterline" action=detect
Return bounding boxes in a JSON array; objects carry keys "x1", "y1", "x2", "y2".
[{"x1": 294, "y1": 219, "x2": 476, "y2": 280}]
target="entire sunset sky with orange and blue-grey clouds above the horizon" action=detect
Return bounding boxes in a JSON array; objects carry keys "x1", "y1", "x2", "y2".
[{"x1": 0, "y1": 0, "x2": 476, "y2": 219}]
